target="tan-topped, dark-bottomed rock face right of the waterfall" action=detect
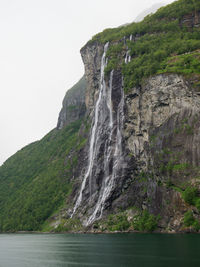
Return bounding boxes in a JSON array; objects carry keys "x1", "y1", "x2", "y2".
[{"x1": 120, "y1": 74, "x2": 200, "y2": 229}]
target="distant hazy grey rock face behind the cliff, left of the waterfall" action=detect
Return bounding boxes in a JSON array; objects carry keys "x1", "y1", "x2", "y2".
[{"x1": 57, "y1": 76, "x2": 86, "y2": 130}]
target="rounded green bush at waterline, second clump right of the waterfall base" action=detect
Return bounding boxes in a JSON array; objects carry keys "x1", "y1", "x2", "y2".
[{"x1": 133, "y1": 210, "x2": 160, "y2": 232}]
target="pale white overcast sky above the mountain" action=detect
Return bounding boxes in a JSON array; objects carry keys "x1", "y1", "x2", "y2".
[{"x1": 0, "y1": 0, "x2": 174, "y2": 165}]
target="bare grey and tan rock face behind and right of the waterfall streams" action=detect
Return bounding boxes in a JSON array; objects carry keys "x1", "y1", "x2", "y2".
[{"x1": 71, "y1": 41, "x2": 200, "y2": 230}]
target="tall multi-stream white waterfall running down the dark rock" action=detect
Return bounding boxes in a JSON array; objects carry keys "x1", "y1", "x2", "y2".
[{"x1": 71, "y1": 43, "x2": 124, "y2": 225}]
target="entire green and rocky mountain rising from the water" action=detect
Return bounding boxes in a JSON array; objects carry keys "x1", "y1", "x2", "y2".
[{"x1": 0, "y1": 0, "x2": 200, "y2": 232}]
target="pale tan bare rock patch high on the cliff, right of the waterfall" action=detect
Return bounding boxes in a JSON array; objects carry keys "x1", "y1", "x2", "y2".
[{"x1": 125, "y1": 74, "x2": 200, "y2": 168}]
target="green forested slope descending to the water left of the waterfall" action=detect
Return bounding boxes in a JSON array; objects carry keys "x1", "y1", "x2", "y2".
[{"x1": 0, "y1": 121, "x2": 83, "y2": 231}]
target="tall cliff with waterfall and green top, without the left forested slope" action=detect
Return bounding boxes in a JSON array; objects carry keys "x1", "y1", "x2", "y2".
[{"x1": 63, "y1": 1, "x2": 200, "y2": 231}]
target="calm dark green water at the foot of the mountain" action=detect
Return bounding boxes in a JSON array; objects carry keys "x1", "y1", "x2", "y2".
[{"x1": 0, "y1": 234, "x2": 200, "y2": 267}]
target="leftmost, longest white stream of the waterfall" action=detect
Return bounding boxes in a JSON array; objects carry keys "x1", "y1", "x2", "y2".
[{"x1": 71, "y1": 43, "x2": 111, "y2": 217}]
